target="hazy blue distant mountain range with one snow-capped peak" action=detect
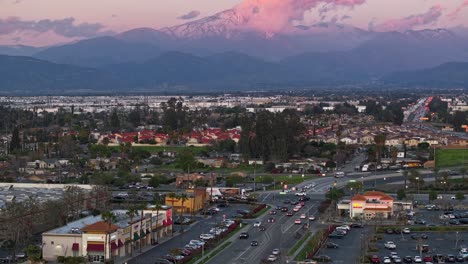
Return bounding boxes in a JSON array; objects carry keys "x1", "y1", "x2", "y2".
[{"x1": 0, "y1": 9, "x2": 468, "y2": 91}]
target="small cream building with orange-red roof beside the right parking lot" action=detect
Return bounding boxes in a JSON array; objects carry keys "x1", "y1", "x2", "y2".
[{"x1": 337, "y1": 191, "x2": 393, "y2": 220}]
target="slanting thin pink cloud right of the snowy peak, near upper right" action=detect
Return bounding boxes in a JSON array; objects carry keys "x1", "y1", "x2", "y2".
[{"x1": 370, "y1": 5, "x2": 442, "y2": 31}]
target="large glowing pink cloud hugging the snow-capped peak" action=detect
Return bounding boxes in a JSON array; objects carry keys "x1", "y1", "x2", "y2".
[{"x1": 235, "y1": 0, "x2": 366, "y2": 33}]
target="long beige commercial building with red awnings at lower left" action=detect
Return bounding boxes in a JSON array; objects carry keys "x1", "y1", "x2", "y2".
[{"x1": 42, "y1": 206, "x2": 172, "y2": 263}]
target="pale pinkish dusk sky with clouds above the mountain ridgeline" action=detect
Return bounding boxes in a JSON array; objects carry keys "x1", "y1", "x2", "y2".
[{"x1": 0, "y1": 0, "x2": 468, "y2": 46}]
